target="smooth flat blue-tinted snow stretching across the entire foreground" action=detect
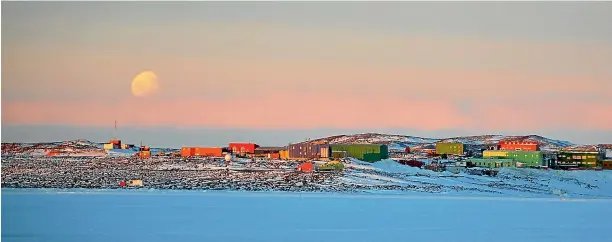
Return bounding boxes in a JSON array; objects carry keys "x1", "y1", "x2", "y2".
[{"x1": 2, "y1": 189, "x2": 612, "y2": 242}]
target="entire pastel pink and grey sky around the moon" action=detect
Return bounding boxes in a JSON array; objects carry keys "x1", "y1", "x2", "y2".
[{"x1": 2, "y1": 2, "x2": 612, "y2": 146}]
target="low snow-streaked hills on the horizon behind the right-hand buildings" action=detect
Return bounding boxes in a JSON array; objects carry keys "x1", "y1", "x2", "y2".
[{"x1": 312, "y1": 133, "x2": 574, "y2": 150}]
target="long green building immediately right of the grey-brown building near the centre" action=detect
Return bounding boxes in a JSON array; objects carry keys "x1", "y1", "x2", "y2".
[{"x1": 331, "y1": 144, "x2": 389, "y2": 162}]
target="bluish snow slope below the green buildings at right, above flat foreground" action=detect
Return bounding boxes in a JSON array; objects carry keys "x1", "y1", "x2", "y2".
[{"x1": 342, "y1": 159, "x2": 612, "y2": 198}]
